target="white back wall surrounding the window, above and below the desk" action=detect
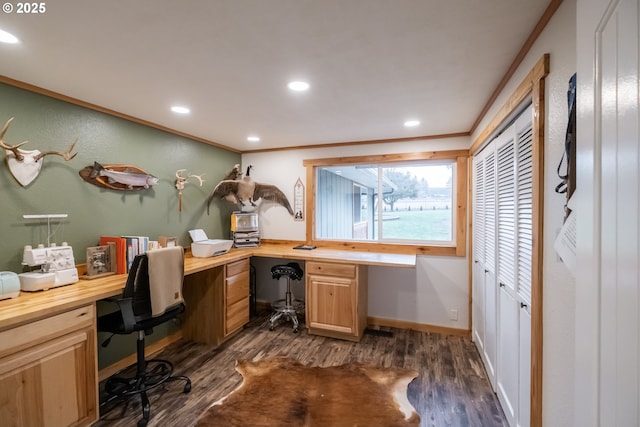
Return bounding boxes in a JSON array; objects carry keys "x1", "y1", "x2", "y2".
[{"x1": 242, "y1": 137, "x2": 470, "y2": 329}]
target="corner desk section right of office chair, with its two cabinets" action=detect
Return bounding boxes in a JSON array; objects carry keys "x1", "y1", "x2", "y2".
[{"x1": 182, "y1": 244, "x2": 416, "y2": 345}]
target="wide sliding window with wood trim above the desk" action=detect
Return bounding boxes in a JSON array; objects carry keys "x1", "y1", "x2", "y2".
[{"x1": 304, "y1": 150, "x2": 468, "y2": 256}]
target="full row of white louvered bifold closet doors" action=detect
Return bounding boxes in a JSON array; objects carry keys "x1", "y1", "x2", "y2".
[{"x1": 473, "y1": 106, "x2": 533, "y2": 427}]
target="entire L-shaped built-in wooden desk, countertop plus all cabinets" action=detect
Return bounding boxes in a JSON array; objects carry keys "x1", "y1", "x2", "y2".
[{"x1": 0, "y1": 244, "x2": 416, "y2": 426}]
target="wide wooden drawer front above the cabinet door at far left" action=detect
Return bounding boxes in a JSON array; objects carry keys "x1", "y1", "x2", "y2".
[{"x1": 0, "y1": 305, "x2": 96, "y2": 357}]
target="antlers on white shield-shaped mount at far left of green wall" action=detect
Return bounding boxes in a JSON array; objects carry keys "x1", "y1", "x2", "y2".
[{"x1": 0, "y1": 117, "x2": 78, "y2": 187}]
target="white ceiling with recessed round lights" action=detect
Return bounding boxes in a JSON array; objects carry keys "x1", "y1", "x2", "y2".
[{"x1": 0, "y1": 0, "x2": 549, "y2": 151}]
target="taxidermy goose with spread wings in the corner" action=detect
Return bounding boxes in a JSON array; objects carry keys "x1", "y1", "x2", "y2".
[{"x1": 207, "y1": 164, "x2": 293, "y2": 216}]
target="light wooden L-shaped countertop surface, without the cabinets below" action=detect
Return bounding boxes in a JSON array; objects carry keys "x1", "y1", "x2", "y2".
[{"x1": 0, "y1": 243, "x2": 416, "y2": 330}]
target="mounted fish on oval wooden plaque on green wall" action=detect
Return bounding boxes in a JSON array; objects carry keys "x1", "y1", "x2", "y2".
[{"x1": 80, "y1": 162, "x2": 158, "y2": 191}]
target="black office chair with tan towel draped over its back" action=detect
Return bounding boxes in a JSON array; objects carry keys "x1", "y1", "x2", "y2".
[{"x1": 98, "y1": 246, "x2": 191, "y2": 427}]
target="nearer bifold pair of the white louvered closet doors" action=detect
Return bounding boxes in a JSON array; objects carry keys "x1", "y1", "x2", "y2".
[{"x1": 496, "y1": 103, "x2": 533, "y2": 426}]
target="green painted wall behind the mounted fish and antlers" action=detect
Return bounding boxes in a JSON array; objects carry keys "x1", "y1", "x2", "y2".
[{"x1": 0, "y1": 84, "x2": 240, "y2": 367}]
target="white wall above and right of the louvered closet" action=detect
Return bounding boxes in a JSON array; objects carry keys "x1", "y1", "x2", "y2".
[{"x1": 472, "y1": 0, "x2": 580, "y2": 426}]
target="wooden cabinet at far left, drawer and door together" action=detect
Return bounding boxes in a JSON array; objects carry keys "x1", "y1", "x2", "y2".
[{"x1": 0, "y1": 304, "x2": 98, "y2": 427}]
